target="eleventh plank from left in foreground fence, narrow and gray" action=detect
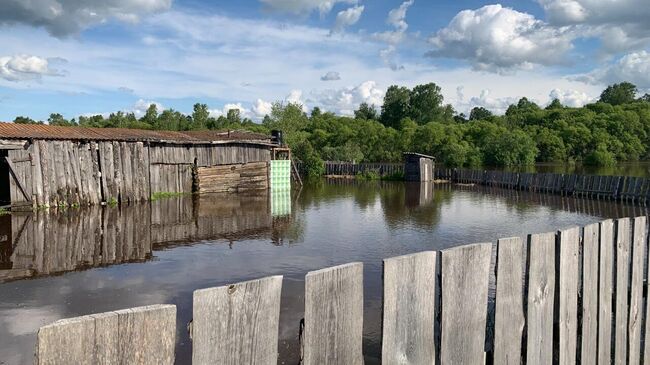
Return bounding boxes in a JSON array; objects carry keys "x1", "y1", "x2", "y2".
[{"x1": 614, "y1": 218, "x2": 630, "y2": 364}]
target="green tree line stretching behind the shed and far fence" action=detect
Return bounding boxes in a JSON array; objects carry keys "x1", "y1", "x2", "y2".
[{"x1": 14, "y1": 82, "x2": 650, "y2": 175}]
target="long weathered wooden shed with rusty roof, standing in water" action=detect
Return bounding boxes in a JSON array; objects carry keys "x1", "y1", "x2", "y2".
[{"x1": 0, "y1": 123, "x2": 279, "y2": 209}]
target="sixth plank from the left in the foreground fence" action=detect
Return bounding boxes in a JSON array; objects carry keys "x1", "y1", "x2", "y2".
[{"x1": 494, "y1": 238, "x2": 525, "y2": 365}]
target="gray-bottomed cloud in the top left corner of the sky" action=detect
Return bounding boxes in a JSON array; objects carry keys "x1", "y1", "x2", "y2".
[{"x1": 0, "y1": 0, "x2": 172, "y2": 37}]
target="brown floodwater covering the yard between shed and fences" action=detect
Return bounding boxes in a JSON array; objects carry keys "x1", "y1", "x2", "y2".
[{"x1": 0, "y1": 180, "x2": 647, "y2": 364}]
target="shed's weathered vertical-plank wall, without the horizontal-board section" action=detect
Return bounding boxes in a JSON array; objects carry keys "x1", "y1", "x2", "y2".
[{"x1": 7, "y1": 140, "x2": 271, "y2": 209}]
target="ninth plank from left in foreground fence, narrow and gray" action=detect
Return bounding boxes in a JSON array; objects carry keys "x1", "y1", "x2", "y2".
[{"x1": 580, "y1": 223, "x2": 600, "y2": 365}]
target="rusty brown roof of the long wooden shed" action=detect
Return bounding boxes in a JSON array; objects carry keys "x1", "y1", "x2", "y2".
[{"x1": 0, "y1": 123, "x2": 271, "y2": 144}]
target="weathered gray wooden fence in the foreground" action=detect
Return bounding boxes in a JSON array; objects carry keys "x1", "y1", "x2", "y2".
[{"x1": 37, "y1": 217, "x2": 650, "y2": 365}]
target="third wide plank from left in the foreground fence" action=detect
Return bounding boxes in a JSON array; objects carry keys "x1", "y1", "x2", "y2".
[{"x1": 302, "y1": 263, "x2": 363, "y2": 365}]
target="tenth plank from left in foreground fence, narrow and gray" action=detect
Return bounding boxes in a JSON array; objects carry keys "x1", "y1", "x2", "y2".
[{"x1": 598, "y1": 219, "x2": 614, "y2": 365}]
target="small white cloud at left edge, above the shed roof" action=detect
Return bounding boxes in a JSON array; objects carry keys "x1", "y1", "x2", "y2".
[{"x1": 0, "y1": 54, "x2": 61, "y2": 81}]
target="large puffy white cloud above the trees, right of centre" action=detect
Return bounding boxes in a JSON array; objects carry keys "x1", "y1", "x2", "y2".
[{"x1": 428, "y1": 5, "x2": 572, "y2": 73}]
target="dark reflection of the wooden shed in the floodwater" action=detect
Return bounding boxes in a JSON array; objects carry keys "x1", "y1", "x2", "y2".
[{"x1": 0, "y1": 193, "x2": 296, "y2": 282}]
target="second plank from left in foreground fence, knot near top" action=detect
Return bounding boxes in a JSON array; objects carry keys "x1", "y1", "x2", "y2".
[{"x1": 192, "y1": 276, "x2": 282, "y2": 365}]
